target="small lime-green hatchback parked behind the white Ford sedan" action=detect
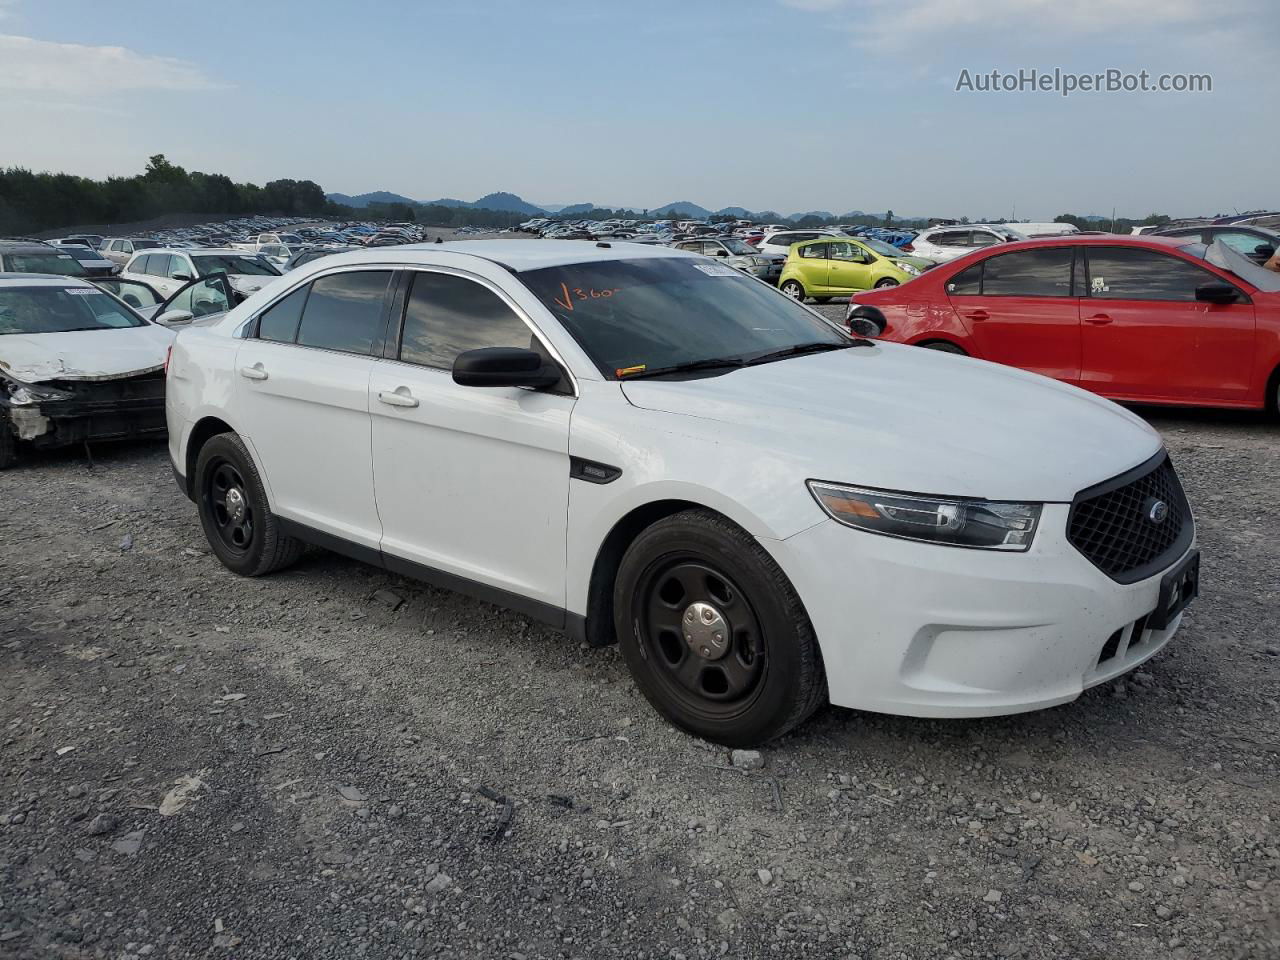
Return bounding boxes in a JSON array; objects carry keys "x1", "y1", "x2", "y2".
[{"x1": 778, "y1": 237, "x2": 934, "y2": 303}]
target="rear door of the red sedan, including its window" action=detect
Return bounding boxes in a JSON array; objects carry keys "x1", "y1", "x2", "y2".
[{"x1": 946, "y1": 247, "x2": 1080, "y2": 384}]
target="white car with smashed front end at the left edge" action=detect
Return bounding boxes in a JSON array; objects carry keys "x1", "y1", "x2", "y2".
[{"x1": 0, "y1": 274, "x2": 173, "y2": 470}]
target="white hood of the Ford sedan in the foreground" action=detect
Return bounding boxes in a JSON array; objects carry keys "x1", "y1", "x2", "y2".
[{"x1": 622, "y1": 343, "x2": 1161, "y2": 502}]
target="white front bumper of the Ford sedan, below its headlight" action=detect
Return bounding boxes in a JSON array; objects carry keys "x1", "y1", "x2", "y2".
[{"x1": 762, "y1": 504, "x2": 1194, "y2": 717}]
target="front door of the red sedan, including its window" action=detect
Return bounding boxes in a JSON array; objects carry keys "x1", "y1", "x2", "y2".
[{"x1": 1080, "y1": 247, "x2": 1254, "y2": 403}]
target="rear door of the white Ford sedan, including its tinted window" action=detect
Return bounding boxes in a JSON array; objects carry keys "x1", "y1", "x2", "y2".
[{"x1": 236, "y1": 269, "x2": 392, "y2": 552}]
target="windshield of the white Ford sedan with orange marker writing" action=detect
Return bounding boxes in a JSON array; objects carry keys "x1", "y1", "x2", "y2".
[{"x1": 520, "y1": 257, "x2": 849, "y2": 379}]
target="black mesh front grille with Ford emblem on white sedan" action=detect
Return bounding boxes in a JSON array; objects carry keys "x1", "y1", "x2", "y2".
[{"x1": 1068, "y1": 452, "x2": 1194, "y2": 584}]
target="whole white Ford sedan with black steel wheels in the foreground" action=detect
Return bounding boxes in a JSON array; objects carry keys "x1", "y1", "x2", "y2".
[{"x1": 168, "y1": 241, "x2": 1198, "y2": 745}]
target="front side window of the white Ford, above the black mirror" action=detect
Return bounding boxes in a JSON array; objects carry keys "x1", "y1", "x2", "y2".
[{"x1": 401, "y1": 273, "x2": 534, "y2": 370}]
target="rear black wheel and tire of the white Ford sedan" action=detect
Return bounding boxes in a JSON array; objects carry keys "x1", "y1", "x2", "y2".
[{"x1": 195, "y1": 434, "x2": 306, "y2": 577}]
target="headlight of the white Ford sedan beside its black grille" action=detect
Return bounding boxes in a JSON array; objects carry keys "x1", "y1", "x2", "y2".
[{"x1": 809, "y1": 480, "x2": 1043, "y2": 552}]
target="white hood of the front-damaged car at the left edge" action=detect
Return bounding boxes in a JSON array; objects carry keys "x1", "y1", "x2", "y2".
[{"x1": 0, "y1": 324, "x2": 173, "y2": 383}]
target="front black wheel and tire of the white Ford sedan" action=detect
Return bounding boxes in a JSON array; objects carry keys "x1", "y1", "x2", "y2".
[{"x1": 613, "y1": 509, "x2": 827, "y2": 746}]
